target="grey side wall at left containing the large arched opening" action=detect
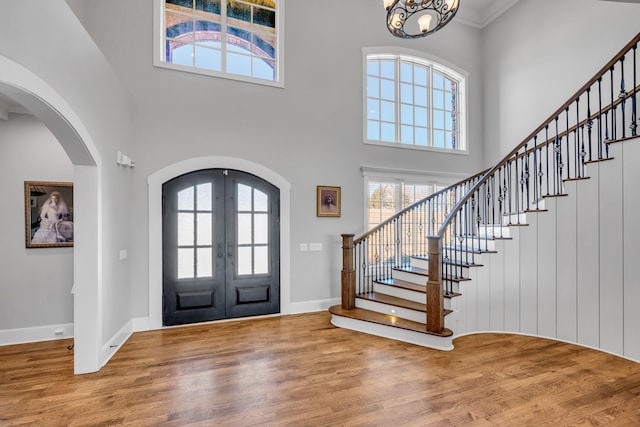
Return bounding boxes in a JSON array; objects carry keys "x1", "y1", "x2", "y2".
[{"x1": 0, "y1": 0, "x2": 133, "y2": 370}]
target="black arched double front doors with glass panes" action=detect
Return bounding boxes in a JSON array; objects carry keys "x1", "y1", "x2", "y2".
[{"x1": 162, "y1": 169, "x2": 280, "y2": 326}]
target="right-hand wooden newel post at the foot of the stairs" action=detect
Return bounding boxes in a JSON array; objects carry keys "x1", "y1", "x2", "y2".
[{"x1": 427, "y1": 236, "x2": 444, "y2": 334}]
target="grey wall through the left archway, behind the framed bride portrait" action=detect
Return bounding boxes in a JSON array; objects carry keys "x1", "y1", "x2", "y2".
[{"x1": 0, "y1": 114, "x2": 73, "y2": 332}]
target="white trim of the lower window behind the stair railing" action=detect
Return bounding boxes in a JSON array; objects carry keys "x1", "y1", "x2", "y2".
[{"x1": 360, "y1": 166, "x2": 469, "y2": 232}]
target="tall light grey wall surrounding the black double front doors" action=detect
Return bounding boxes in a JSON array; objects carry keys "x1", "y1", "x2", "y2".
[{"x1": 70, "y1": 0, "x2": 483, "y2": 317}]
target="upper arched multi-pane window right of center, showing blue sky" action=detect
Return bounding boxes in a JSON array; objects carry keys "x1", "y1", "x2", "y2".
[{"x1": 364, "y1": 48, "x2": 467, "y2": 151}]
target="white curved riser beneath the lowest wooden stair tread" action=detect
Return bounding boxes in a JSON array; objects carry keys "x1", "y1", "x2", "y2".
[{"x1": 331, "y1": 314, "x2": 453, "y2": 351}]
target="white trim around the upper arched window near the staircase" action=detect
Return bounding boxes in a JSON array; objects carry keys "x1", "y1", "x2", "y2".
[{"x1": 362, "y1": 46, "x2": 469, "y2": 155}]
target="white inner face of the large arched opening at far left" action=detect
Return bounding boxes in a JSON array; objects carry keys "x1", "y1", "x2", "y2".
[{"x1": 0, "y1": 55, "x2": 102, "y2": 374}]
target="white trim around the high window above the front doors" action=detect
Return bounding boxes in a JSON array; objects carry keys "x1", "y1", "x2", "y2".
[{"x1": 153, "y1": 0, "x2": 285, "y2": 88}]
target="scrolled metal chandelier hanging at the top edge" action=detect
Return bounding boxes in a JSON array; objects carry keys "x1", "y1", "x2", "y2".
[{"x1": 384, "y1": 0, "x2": 459, "y2": 39}]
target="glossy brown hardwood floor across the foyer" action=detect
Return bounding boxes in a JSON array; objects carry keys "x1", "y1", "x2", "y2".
[{"x1": 0, "y1": 312, "x2": 640, "y2": 426}]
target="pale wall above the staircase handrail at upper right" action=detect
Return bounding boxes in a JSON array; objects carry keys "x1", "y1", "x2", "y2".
[{"x1": 482, "y1": 0, "x2": 640, "y2": 164}]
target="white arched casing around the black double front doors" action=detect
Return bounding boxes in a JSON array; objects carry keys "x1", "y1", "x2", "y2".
[{"x1": 147, "y1": 156, "x2": 291, "y2": 329}]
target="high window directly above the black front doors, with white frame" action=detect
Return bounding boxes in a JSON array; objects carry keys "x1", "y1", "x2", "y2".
[{"x1": 154, "y1": 0, "x2": 283, "y2": 86}]
